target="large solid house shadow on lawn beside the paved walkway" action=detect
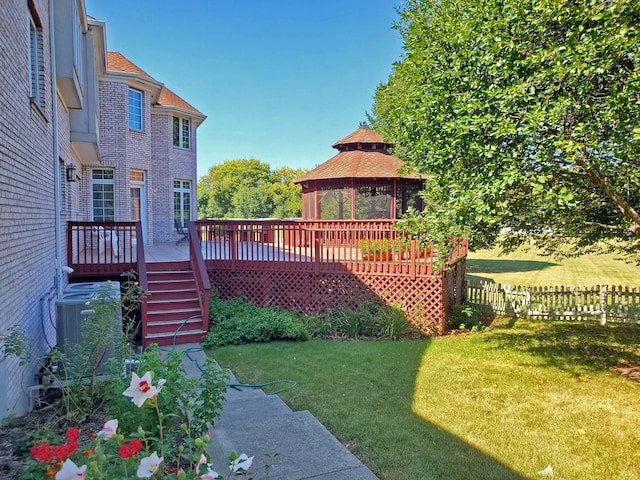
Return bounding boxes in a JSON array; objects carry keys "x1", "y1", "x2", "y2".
[{"x1": 212, "y1": 340, "x2": 527, "y2": 480}]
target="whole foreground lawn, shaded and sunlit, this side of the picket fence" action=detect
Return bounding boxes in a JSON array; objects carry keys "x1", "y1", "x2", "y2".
[{"x1": 210, "y1": 320, "x2": 640, "y2": 480}]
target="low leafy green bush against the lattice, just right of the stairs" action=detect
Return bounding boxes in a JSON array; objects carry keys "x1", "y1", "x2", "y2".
[{"x1": 204, "y1": 296, "x2": 310, "y2": 348}]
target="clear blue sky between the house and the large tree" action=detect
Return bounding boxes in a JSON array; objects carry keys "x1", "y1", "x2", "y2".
[{"x1": 86, "y1": 0, "x2": 402, "y2": 175}]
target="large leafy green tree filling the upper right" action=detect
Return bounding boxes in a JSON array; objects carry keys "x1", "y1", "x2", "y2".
[{"x1": 372, "y1": 0, "x2": 640, "y2": 260}]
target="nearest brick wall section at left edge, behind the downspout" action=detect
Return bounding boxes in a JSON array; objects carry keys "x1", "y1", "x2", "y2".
[{"x1": 0, "y1": 0, "x2": 71, "y2": 419}]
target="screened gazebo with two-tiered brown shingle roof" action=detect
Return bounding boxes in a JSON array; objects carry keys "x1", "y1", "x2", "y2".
[{"x1": 296, "y1": 123, "x2": 423, "y2": 220}]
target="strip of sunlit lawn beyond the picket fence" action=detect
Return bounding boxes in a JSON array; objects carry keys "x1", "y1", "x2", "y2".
[{"x1": 467, "y1": 249, "x2": 640, "y2": 287}]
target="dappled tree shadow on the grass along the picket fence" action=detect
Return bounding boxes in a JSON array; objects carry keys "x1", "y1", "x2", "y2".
[{"x1": 486, "y1": 320, "x2": 640, "y2": 375}]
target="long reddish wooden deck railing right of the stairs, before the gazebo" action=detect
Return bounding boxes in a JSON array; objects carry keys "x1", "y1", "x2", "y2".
[{"x1": 195, "y1": 220, "x2": 466, "y2": 278}]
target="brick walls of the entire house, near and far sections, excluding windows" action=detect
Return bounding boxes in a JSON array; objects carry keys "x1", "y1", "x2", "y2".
[{"x1": 0, "y1": 0, "x2": 205, "y2": 422}]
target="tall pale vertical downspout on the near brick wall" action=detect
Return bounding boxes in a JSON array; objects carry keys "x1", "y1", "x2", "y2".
[{"x1": 49, "y1": 0, "x2": 62, "y2": 292}]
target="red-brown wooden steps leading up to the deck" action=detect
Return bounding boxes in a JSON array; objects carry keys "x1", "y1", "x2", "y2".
[{"x1": 142, "y1": 262, "x2": 208, "y2": 348}]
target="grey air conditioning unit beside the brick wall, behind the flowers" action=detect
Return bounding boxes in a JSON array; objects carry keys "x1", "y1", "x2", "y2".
[{"x1": 56, "y1": 282, "x2": 122, "y2": 374}]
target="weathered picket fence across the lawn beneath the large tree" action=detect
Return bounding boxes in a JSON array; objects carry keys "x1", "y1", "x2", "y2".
[{"x1": 466, "y1": 282, "x2": 640, "y2": 325}]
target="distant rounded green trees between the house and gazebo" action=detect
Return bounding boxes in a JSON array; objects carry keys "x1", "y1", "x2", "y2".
[{"x1": 198, "y1": 158, "x2": 305, "y2": 218}]
